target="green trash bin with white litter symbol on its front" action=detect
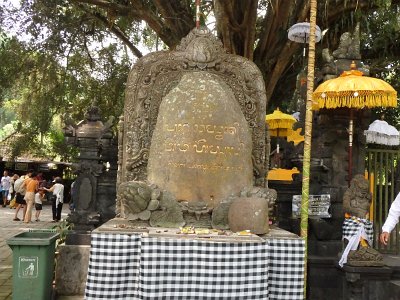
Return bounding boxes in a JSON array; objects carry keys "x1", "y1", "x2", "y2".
[{"x1": 7, "y1": 231, "x2": 59, "y2": 300}]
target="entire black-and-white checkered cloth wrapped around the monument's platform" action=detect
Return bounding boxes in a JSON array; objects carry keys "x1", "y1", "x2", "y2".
[{"x1": 85, "y1": 233, "x2": 304, "y2": 300}]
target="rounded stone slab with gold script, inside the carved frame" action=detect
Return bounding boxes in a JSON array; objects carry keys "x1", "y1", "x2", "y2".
[{"x1": 147, "y1": 71, "x2": 253, "y2": 208}]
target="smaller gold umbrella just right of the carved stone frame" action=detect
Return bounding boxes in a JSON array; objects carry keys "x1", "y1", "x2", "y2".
[{"x1": 265, "y1": 108, "x2": 297, "y2": 153}]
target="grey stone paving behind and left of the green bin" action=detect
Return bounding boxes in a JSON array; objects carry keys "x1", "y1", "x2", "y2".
[{"x1": 0, "y1": 204, "x2": 72, "y2": 300}]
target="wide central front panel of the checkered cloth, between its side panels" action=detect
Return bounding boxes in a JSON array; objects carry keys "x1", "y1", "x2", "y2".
[{"x1": 139, "y1": 238, "x2": 268, "y2": 300}]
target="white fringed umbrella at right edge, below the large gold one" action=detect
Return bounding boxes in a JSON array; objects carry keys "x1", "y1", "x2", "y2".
[{"x1": 364, "y1": 120, "x2": 400, "y2": 146}]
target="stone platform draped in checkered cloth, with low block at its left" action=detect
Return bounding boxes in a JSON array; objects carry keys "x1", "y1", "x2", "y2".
[{"x1": 56, "y1": 218, "x2": 304, "y2": 300}]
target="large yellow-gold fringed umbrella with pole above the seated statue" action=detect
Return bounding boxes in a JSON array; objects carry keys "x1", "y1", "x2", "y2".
[{"x1": 312, "y1": 62, "x2": 397, "y2": 183}]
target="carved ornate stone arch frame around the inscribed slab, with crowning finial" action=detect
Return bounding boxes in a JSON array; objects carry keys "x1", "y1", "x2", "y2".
[{"x1": 117, "y1": 29, "x2": 269, "y2": 212}]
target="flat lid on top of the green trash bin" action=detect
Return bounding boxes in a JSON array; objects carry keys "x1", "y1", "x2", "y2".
[{"x1": 7, "y1": 231, "x2": 60, "y2": 246}]
